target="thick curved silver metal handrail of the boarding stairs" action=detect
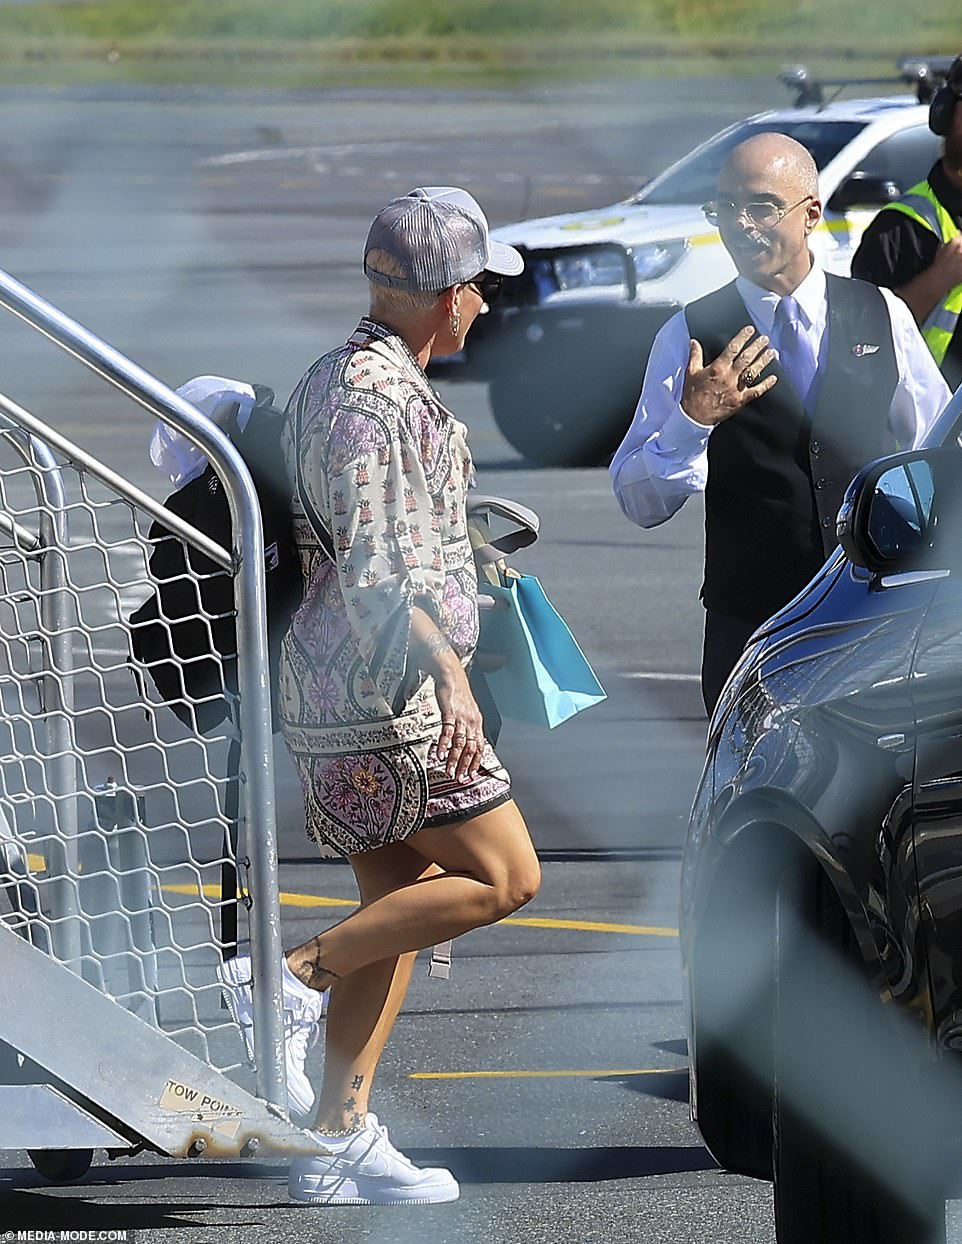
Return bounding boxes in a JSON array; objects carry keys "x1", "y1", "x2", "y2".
[{"x1": 0, "y1": 270, "x2": 286, "y2": 1107}]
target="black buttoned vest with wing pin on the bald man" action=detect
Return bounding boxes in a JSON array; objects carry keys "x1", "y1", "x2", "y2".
[{"x1": 684, "y1": 275, "x2": 899, "y2": 626}]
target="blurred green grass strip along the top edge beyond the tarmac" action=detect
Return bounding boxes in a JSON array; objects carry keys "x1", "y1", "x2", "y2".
[{"x1": 0, "y1": 0, "x2": 958, "y2": 87}]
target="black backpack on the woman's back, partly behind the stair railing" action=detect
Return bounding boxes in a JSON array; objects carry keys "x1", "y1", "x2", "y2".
[{"x1": 129, "y1": 384, "x2": 302, "y2": 733}]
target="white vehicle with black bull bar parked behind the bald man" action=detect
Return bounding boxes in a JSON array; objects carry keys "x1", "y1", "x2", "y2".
[{"x1": 463, "y1": 57, "x2": 952, "y2": 467}]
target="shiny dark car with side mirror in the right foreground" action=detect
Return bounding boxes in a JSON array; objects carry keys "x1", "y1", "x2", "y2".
[{"x1": 682, "y1": 391, "x2": 962, "y2": 1244}]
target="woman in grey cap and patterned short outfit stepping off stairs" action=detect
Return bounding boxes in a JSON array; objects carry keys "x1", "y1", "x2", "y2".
[{"x1": 226, "y1": 187, "x2": 540, "y2": 1204}]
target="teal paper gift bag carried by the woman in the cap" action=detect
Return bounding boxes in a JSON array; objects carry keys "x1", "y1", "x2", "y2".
[{"x1": 478, "y1": 575, "x2": 605, "y2": 728}]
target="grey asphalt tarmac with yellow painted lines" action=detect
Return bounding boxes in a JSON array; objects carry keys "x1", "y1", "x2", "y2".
[{"x1": 0, "y1": 80, "x2": 780, "y2": 1244}]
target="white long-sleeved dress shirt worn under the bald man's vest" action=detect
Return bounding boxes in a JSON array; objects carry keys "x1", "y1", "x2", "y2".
[{"x1": 610, "y1": 265, "x2": 951, "y2": 527}]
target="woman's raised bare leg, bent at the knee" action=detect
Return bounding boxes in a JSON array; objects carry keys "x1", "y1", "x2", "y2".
[{"x1": 287, "y1": 801, "x2": 540, "y2": 989}]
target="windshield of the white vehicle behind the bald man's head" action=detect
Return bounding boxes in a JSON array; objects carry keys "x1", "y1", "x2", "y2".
[{"x1": 631, "y1": 118, "x2": 865, "y2": 205}]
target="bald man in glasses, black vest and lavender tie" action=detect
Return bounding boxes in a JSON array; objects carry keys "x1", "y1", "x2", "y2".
[{"x1": 611, "y1": 132, "x2": 950, "y2": 713}]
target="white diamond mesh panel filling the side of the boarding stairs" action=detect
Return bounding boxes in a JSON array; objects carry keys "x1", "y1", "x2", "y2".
[{"x1": 0, "y1": 420, "x2": 251, "y2": 1070}]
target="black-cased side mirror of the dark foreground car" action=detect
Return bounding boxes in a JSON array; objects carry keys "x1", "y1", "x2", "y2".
[{"x1": 836, "y1": 447, "x2": 962, "y2": 575}]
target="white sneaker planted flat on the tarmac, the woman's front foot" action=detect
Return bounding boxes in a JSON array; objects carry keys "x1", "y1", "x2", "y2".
[{"x1": 287, "y1": 1115, "x2": 460, "y2": 1205}]
